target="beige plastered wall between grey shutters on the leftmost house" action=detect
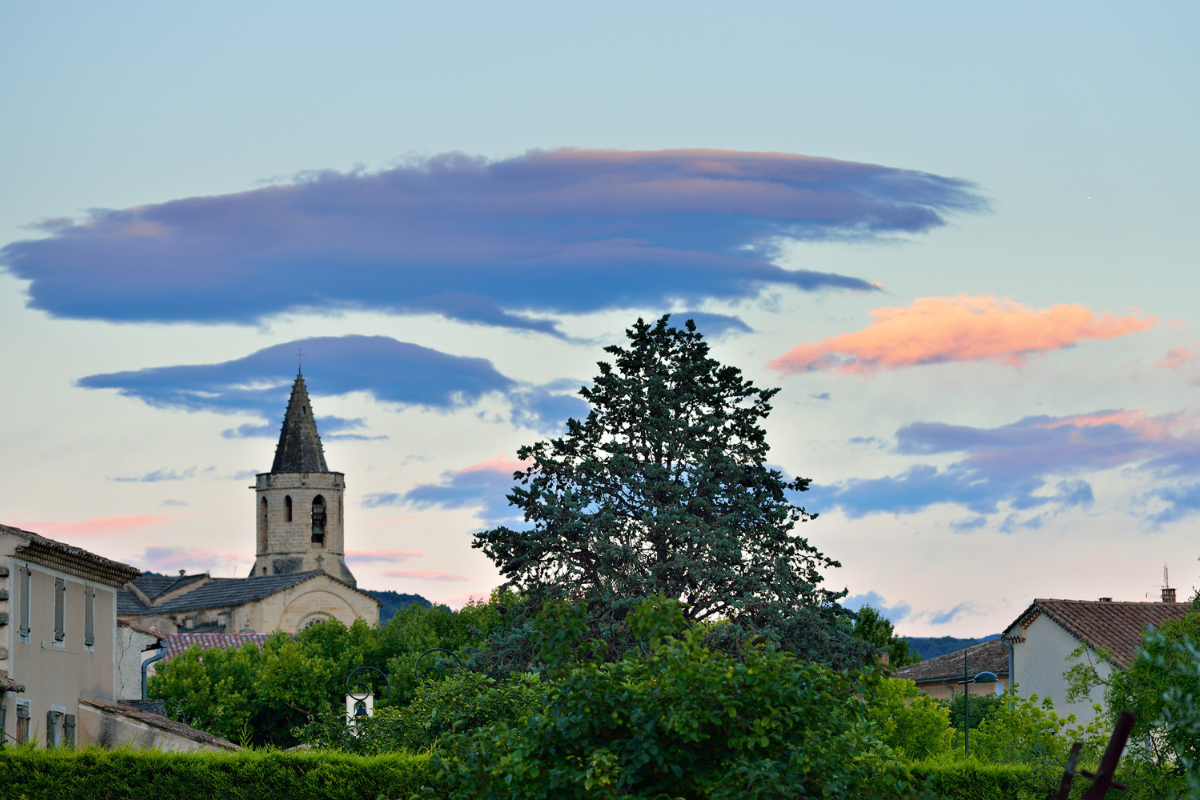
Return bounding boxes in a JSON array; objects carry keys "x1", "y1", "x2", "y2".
[{"x1": 0, "y1": 536, "x2": 116, "y2": 741}]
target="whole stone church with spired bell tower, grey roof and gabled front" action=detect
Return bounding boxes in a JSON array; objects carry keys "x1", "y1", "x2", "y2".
[{"x1": 116, "y1": 374, "x2": 379, "y2": 633}]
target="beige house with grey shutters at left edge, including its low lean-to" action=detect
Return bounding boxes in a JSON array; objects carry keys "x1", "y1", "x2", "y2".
[{"x1": 0, "y1": 525, "x2": 236, "y2": 750}]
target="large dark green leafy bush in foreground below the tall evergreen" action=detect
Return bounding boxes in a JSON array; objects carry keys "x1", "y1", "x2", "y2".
[{"x1": 433, "y1": 595, "x2": 905, "y2": 800}]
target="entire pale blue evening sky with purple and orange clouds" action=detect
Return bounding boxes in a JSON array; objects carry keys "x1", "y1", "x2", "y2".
[{"x1": 0, "y1": 2, "x2": 1200, "y2": 636}]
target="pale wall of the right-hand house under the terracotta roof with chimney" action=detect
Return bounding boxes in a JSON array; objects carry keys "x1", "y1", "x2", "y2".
[{"x1": 1009, "y1": 614, "x2": 1112, "y2": 724}]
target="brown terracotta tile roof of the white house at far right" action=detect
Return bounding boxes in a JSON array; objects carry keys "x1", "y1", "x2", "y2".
[{"x1": 1004, "y1": 600, "x2": 1190, "y2": 668}]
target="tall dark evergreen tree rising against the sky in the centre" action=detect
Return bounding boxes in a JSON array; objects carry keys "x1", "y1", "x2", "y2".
[{"x1": 473, "y1": 317, "x2": 869, "y2": 666}]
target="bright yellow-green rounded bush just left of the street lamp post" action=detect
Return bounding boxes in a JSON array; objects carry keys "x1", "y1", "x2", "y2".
[{"x1": 863, "y1": 678, "x2": 954, "y2": 760}]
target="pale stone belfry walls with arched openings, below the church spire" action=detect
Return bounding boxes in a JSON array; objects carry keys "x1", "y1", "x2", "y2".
[{"x1": 253, "y1": 473, "x2": 356, "y2": 585}]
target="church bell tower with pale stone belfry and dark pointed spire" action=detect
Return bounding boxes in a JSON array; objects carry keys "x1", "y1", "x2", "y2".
[{"x1": 252, "y1": 374, "x2": 358, "y2": 587}]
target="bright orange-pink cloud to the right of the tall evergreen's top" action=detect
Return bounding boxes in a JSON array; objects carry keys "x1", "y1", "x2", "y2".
[{"x1": 767, "y1": 295, "x2": 1157, "y2": 373}]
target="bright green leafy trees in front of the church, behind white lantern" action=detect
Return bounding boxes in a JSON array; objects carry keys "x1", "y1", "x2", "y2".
[{"x1": 149, "y1": 594, "x2": 516, "y2": 746}]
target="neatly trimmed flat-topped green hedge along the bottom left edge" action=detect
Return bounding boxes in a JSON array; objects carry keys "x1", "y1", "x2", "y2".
[{"x1": 0, "y1": 747, "x2": 444, "y2": 800}]
